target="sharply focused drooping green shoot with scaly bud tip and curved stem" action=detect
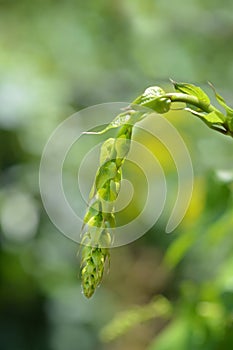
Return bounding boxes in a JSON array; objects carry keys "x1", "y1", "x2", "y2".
[{"x1": 80, "y1": 80, "x2": 233, "y2": 298}]
